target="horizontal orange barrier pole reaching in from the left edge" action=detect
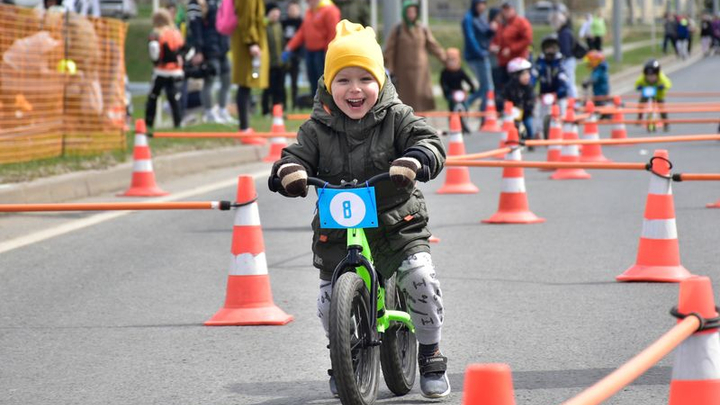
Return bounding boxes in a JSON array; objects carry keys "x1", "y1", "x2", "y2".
[{"x1": 0, "y1": 201, "x2": 232, "y2": 212}]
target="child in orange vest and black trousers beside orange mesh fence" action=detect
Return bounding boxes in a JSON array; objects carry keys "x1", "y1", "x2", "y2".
[{"x1": 145, "y1": 8, "x2": 185, "y2": 130}]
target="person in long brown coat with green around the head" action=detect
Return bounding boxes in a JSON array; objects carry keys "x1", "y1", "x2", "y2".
[{"x1": 384, "y1": 0, "x2": 445, "y2": 111}]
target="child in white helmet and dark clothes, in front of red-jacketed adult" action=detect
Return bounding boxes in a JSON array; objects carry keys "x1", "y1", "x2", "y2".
[{"x1": 503, "y1": 58, "x2": 535, "y2": 145}]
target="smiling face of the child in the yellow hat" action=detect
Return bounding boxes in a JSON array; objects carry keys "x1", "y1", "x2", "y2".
[{"x1": 330, "y1": 66, "x2": 380, "y2": 120}]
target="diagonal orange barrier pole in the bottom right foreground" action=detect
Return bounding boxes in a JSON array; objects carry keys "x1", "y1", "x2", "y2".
[{"x1": 562, "y1": 316, "x2": 700, "y2": 405}]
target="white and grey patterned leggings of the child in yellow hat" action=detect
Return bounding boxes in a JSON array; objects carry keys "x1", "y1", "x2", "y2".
[{"x1": 317, "y1": 253, "x2": 444, "y2": 345}]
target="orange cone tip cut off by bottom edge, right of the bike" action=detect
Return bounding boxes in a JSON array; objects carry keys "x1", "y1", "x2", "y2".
[{"x1": 462, "y1": 364, "x2": 515, "y2": 405}]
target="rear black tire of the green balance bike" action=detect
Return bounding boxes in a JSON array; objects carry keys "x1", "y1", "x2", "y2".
[{"x1": 380, "y1": 276, "x2": 417, "y2": 396}]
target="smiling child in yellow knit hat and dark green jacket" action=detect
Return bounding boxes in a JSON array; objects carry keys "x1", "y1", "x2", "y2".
[{"x1": 270, "y1": 20, "x2": 450, "y2": 398}]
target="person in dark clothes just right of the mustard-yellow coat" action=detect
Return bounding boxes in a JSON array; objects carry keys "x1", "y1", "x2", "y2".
[{"x1": 262, "y1": 3, "x2": 285, "y2": 115}]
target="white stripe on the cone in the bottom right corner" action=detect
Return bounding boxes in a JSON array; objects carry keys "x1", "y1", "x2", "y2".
[{"x1": 672, "y1": 332, "x2": 720, "y2": 381}]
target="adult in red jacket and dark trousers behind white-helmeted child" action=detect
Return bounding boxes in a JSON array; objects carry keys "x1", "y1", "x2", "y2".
[{"x1": 490, "y1": 1, "x2": 532, "y2": 108}]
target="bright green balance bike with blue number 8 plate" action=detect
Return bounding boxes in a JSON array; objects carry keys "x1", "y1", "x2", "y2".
[{"x1": 278, "y1": 173, "x2": 417, "y2": 405}]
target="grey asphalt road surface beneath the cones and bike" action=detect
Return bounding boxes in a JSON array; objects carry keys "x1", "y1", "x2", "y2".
[{"x1": 0, "y1": 59, "x2": 720, "y2": 405}]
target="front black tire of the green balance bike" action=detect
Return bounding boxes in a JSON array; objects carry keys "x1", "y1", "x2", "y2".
[{"x1": 330, "y1": 272, "x2": 380, "y2": 405}]
